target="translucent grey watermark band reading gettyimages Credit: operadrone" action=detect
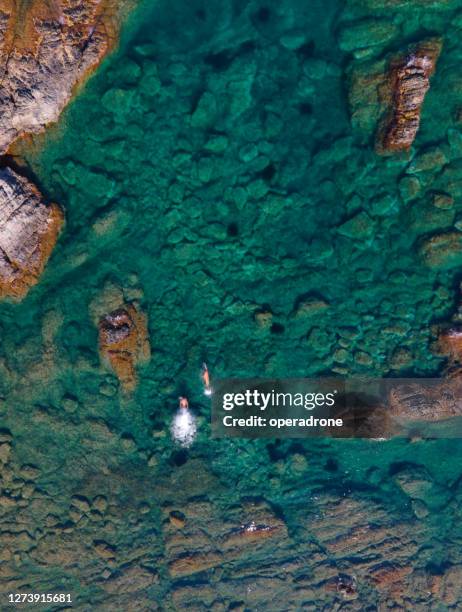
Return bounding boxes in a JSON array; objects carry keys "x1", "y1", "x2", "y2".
[{"x1": 212, "y1": 378, "x2": 462, "y2": 440}]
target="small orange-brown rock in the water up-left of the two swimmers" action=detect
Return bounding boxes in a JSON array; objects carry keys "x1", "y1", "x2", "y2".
[{"x1": 99, "y1": 304, "x2": 150, "y2": 391}]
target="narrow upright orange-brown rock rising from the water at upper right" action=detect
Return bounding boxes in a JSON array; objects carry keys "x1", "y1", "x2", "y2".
[{"x1": 377, "y1": 38, "x2": 441, "y2": 153}]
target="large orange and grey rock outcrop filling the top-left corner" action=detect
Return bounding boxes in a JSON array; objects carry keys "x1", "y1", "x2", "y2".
[{"x1": 0, "y1": 0, "x2": 128, "y2": 153}]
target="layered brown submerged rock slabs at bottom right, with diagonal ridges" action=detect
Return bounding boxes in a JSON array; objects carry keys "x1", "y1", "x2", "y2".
[{"x1": 163, "y1": 473, "x2": 460, "y2": 610}]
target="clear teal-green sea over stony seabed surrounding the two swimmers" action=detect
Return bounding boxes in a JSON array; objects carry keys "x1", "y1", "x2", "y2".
[{"x1": 0, "y1": 0, "x2": 462, "y2": 612}]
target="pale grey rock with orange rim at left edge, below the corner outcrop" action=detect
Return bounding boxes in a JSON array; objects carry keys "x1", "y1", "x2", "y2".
[{"x1": 0, "y1": 168, "x2": 63, "y2": 298}]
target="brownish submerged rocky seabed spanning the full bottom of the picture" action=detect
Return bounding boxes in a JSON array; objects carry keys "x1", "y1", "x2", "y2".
[{"x1": 0, "y1": 428, "x2": 462, "y2": 612}]
